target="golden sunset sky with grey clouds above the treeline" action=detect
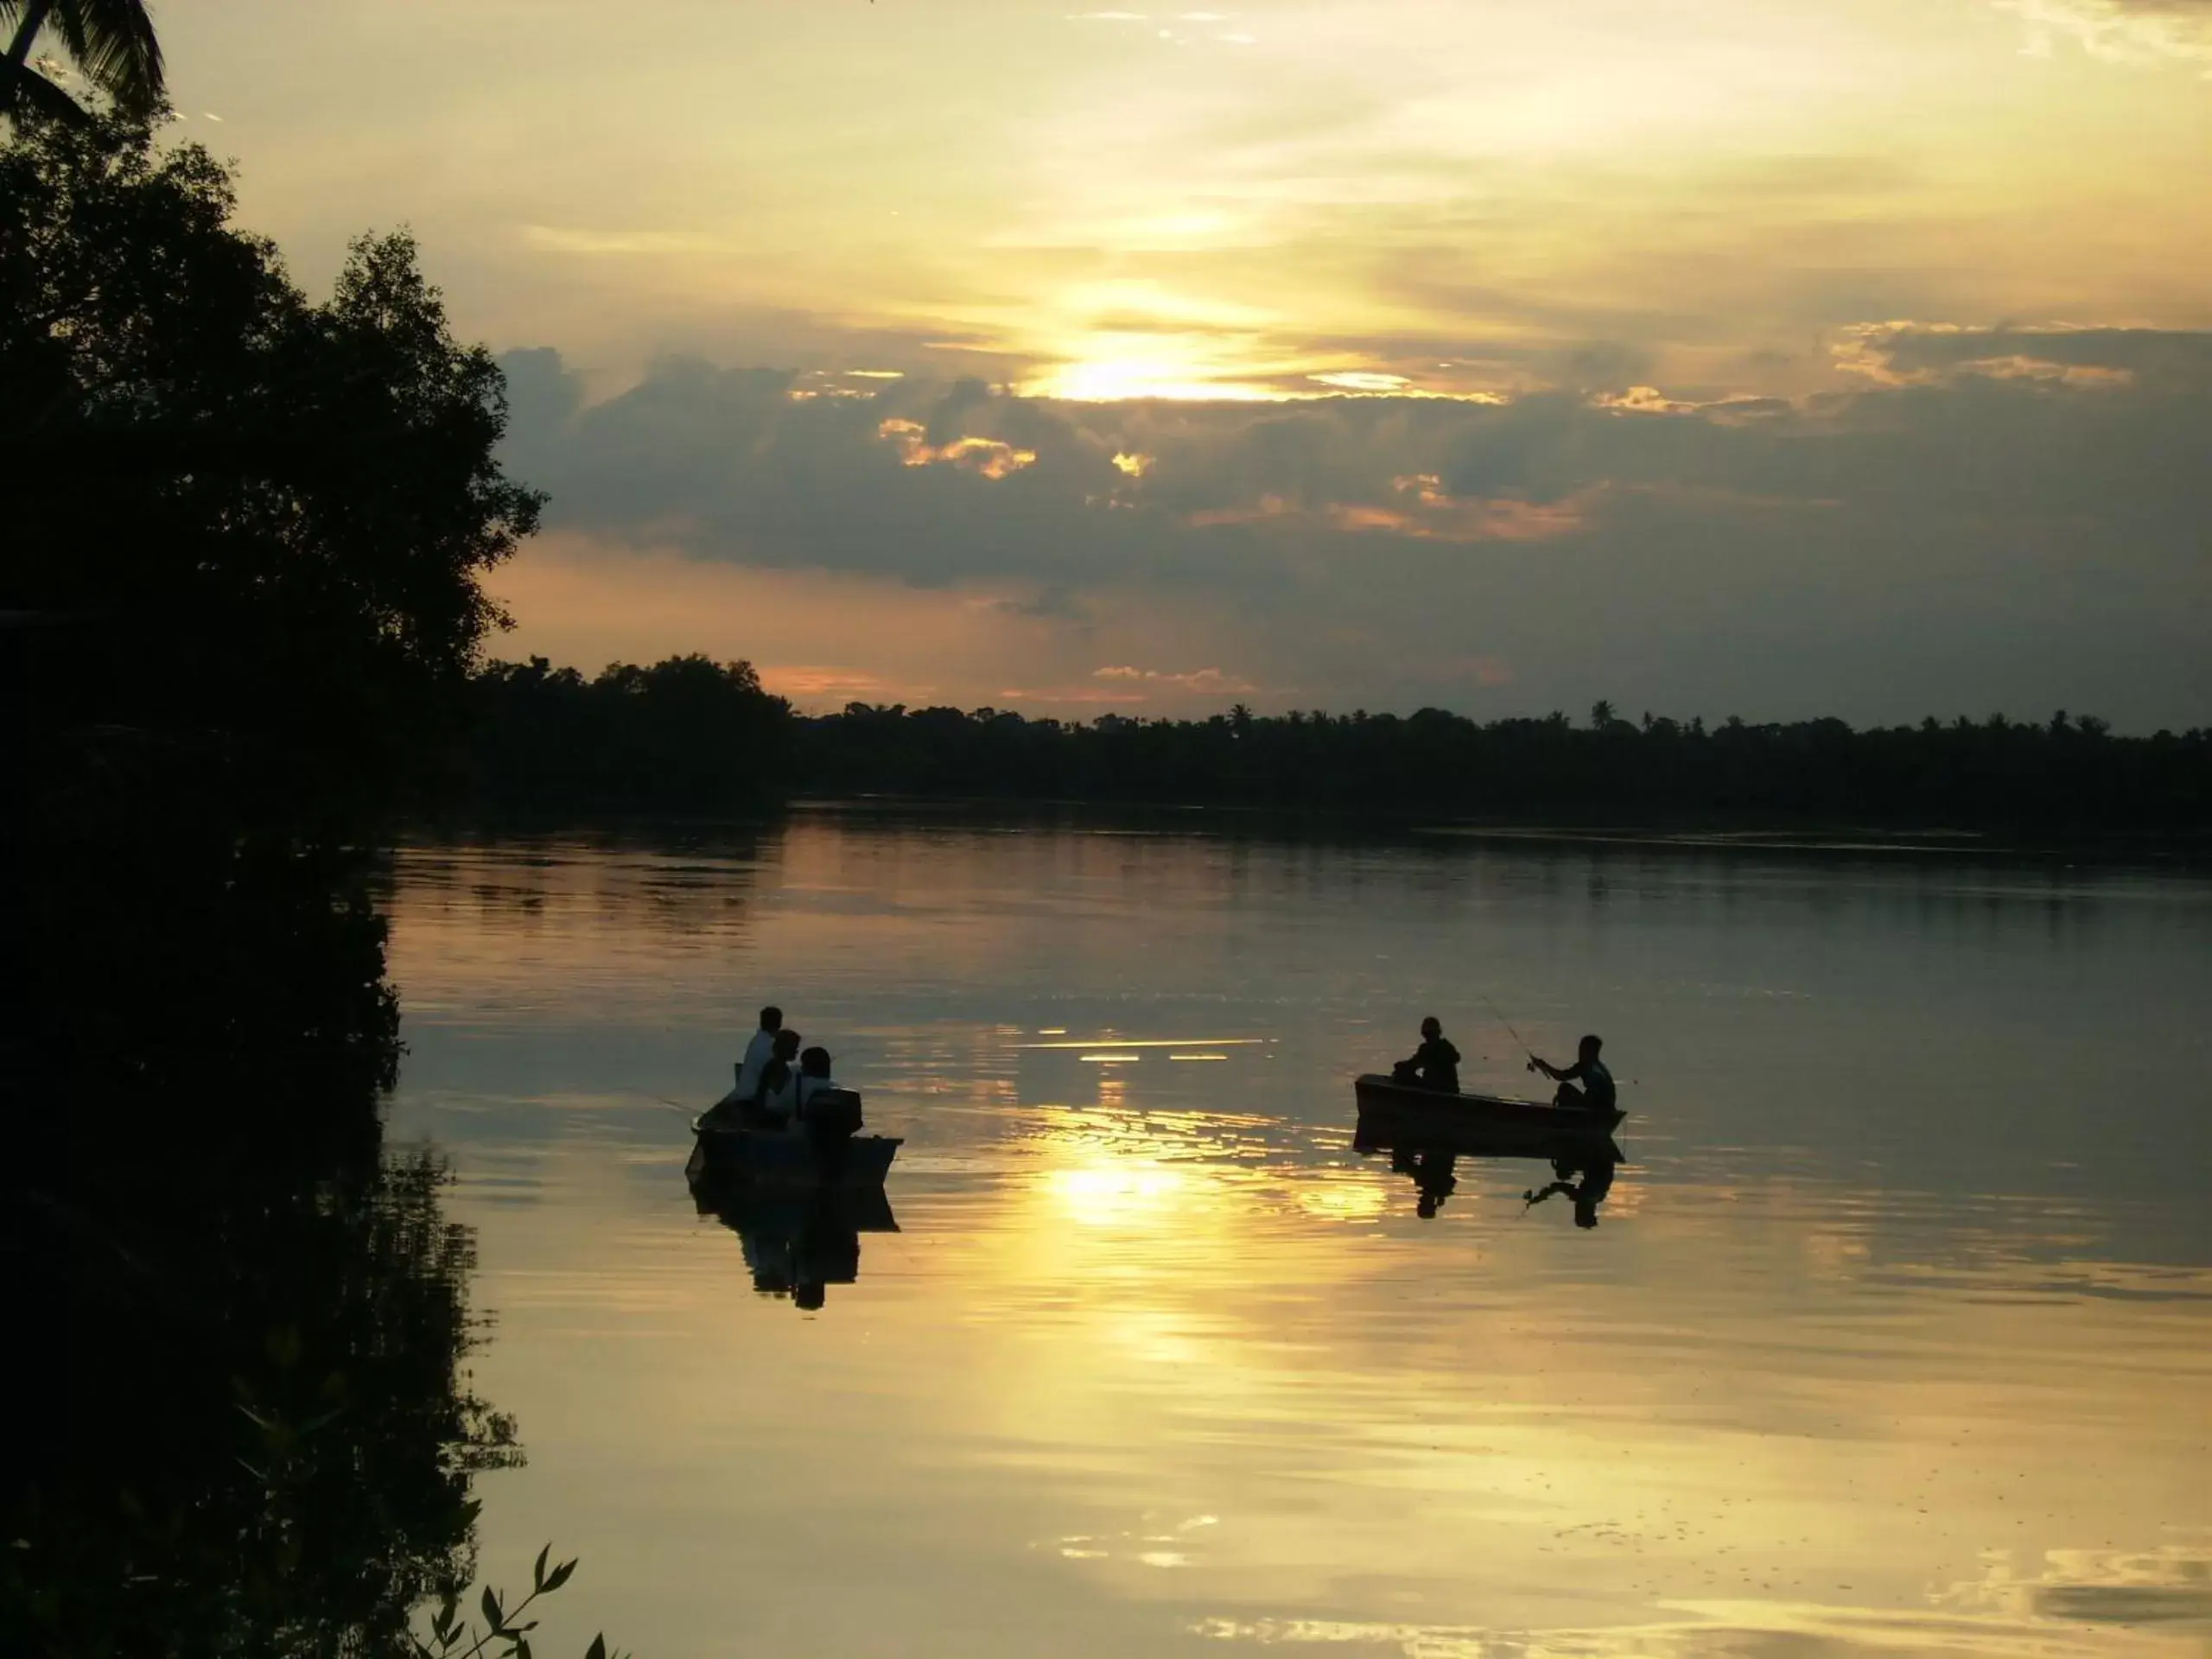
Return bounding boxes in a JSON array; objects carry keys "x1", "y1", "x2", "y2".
[{"x1": 157, "y1": 0, "x2": 2212, "y2": 730}]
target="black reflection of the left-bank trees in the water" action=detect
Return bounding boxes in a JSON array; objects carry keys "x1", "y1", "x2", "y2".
[{"x1": 0, "y1": 852, "x2": 520, "y2": 1655}]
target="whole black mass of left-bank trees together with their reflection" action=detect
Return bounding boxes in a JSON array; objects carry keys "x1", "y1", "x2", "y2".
[{"x1": 0, "y1": 84, "x2": 623, "y2": 1659}]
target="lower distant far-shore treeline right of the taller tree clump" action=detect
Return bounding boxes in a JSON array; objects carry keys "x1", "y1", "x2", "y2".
[{"x1": 790, "y1": 703, "x2": 2212, "y2": 834}]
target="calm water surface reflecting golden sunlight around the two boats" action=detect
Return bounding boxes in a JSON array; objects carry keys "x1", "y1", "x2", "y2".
[{"x1": 390, "y1": 814, "x2": 2212, "y2": 1659}]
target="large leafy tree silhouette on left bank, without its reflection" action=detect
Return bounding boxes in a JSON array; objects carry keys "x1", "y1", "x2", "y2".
[{"x1": 0, "y1": 118, "x2": 540, "y2": 817}]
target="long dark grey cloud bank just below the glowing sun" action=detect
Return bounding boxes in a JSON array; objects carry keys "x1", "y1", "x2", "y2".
[{"x1": 509, "y1": 327, "x2": 2212, "y2": 726}]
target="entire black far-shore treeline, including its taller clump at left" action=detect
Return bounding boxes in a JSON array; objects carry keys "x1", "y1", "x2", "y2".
[{"x1": 465, "y1": 657, "x2": 2212, "y2": 834}]
